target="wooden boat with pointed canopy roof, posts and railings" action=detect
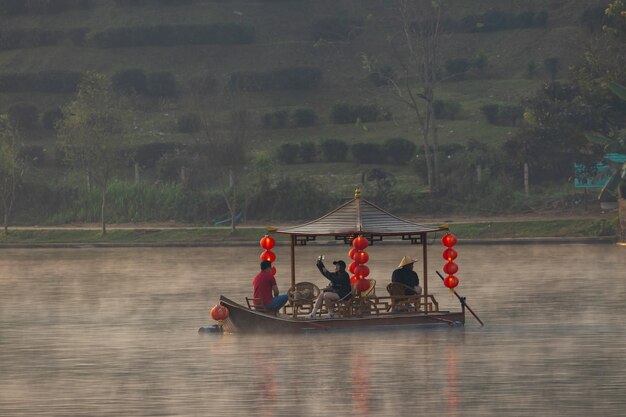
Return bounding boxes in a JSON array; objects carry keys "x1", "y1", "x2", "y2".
[{"x1": 200, "y1": 189, "x2": 483, "y2": 333}]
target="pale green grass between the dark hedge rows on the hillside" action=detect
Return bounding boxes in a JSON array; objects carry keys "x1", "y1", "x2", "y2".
[{"x1": 0, "y1": 0, "x2": 606, "y2": 223}]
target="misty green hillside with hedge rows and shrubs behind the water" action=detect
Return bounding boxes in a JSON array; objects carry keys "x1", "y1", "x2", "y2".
[{"x1": 0, "y1": 0, "x2": 626, "y2": 237}]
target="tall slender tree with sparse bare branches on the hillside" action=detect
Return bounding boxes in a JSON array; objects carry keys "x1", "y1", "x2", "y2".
[{"x1": 363, "y1": 0, "x2": 443, "y2": 193}]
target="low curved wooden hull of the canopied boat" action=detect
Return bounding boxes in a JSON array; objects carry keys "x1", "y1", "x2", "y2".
[{"x1": 220, "y1": 296, "x2": 465, "y2": 333}]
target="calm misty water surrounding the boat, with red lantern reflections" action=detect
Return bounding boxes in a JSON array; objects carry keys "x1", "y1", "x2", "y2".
[{"x1": 0, "y1": 242, "x2": 626, "y2": 417}]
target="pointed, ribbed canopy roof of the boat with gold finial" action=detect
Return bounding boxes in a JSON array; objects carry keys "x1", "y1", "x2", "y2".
[{"x1": 272, "y1": 190, "x2": 448, "y2": 237}]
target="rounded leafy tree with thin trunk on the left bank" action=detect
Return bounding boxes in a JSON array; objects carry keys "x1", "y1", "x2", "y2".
[{"x1": 57, "y1": 73, "x2": 133, "y2": 235}]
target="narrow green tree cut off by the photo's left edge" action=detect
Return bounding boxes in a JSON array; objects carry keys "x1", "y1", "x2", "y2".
[{"x1": 0, "y1": 117, "x2": 24, "y2": 234}]
